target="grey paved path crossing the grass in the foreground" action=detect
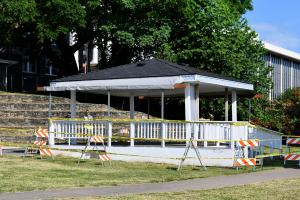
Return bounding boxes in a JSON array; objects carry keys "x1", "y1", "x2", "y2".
[{"x1": 0, "y1": 168, "x2": 300, "y2": 200}]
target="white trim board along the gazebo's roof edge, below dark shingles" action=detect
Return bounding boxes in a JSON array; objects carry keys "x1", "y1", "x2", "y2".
[{"x1": 45, "y1": 75, "x2": 253, "y2": 94}]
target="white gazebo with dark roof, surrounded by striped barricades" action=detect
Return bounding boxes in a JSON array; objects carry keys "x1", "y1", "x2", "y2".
[{"x1": 45, "y1": 59, "x2": 281, "y2": 166}]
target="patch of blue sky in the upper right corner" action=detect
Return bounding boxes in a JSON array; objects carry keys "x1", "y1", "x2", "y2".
[{"x1": 245, "y1": 0, "x2": 300, "y2": 53}]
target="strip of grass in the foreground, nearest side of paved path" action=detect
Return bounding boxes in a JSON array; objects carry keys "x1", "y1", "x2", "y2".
[{"x1": 61, "y1": 178, "x2": 300, "y2": 200}]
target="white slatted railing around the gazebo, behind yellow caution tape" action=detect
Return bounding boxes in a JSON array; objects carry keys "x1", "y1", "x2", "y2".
[{"x1": 49, "y1": 119, "x2": 248, "y2": 147}]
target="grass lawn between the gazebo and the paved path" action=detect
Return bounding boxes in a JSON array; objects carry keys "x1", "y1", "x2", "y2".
[{"x1": 0, "y1": 156, "x2": 268, "y2": 192}]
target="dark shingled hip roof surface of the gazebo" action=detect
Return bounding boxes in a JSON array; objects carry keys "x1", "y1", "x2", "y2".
[{"x1": 53, "y1": 58, "x2": 248, "y2": 82}]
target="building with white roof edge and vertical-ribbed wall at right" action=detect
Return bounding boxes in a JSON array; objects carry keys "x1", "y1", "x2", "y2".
[{"x1": 263, "y1": 42, "x2": 300, "y2": 100}]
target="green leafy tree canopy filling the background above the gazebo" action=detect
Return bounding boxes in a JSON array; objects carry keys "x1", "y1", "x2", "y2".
[{"x1": 0, "y1": 0, "x2": 270, "y2": 92}]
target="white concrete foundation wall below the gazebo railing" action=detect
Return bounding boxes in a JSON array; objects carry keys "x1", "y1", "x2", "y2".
[{"x1": 53, "y1": 145, "x2": 234, "y2": 167}]
